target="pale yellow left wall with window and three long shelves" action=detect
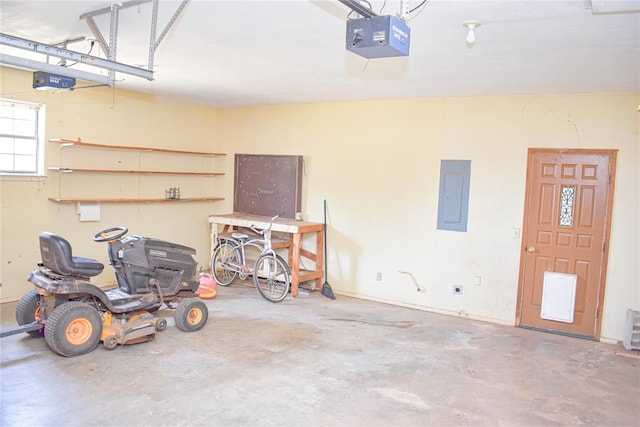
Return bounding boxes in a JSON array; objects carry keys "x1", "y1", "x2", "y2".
[{"x1": 0, "y1": 68, "x2": 224, "y2": 302}]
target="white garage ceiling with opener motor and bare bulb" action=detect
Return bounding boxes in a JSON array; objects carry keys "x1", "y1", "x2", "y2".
[{"x1": 0, "y1": 0, "x2": 640, "y2": 107}]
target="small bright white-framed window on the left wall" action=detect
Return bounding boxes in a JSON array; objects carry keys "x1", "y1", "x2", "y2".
[{"x1": 0, "y1": 99, "x2": 45, "y2": 174}]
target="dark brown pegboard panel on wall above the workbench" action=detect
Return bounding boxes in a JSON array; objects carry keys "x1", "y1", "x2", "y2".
[{"x1": 233, "y1": 154, "x2": 302, "y2": 219}]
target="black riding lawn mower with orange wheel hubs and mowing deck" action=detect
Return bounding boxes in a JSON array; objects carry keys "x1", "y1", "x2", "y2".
[{"x1": 13, "y1": 227, "x2": 209, "y2": 357}]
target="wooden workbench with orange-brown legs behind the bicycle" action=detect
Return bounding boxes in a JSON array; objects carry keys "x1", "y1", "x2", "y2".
[{"x1": 209, "y1": 213, "x2": 324, "y2": 297}]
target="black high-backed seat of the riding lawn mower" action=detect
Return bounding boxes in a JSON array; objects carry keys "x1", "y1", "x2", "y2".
[{"x1": 40, "y1": 231, "x2": 104, "y2": 278}]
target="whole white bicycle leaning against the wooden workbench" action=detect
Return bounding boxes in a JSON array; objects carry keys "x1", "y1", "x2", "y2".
[{"x1": 211, "y1": 214, "x2": 291, "y2": 302}]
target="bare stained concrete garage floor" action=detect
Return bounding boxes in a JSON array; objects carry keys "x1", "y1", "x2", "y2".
[{"x1": 0, "y1": 284, "x2": 640, "y2": 427}]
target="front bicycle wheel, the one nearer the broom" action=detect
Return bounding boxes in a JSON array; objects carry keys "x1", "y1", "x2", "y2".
[{"x1": 253, "y1": 255, "x2": 291, "y2": 302}]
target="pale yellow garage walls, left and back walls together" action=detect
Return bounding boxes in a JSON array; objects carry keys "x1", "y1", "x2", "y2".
[{"x1": 0, "y1": 69, "x2": 640, "y2": 340}]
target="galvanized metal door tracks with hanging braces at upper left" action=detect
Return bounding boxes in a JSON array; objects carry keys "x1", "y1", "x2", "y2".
[{"x1": 0, "y1": 0, "x2": 189, "y2": 86}]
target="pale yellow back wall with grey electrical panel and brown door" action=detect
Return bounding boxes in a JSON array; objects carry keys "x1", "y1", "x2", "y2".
[{"x1": 219, "y1": 95, "x2": 640, "y2": 339}]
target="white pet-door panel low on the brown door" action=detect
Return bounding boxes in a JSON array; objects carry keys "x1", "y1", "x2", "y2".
[{"x1": 540, "y1": 271, "x2": 578, "y2": 323}]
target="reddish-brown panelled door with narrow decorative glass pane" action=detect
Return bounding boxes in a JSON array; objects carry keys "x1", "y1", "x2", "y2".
[{"x1": 516, "y1": 149, "x2": 617, "y2": 339}]
